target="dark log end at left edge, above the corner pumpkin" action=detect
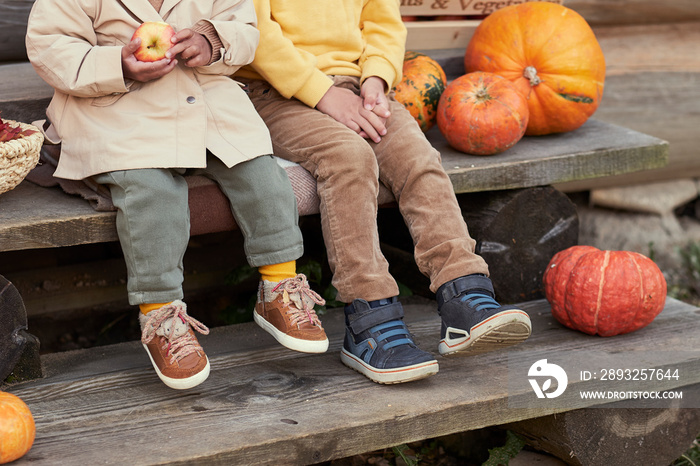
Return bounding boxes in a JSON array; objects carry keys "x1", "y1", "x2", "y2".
[{"x1": 0, "y1": 275, "x2": 41, "y2": 382}]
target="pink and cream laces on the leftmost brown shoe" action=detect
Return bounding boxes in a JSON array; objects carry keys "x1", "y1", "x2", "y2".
[{"x1": 141, "y1": 301, "x2": 209, "y2": 364}]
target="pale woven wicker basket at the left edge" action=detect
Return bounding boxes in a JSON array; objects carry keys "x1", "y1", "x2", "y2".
[{"x1": 0, "y1": 120, "x2": 44, "y2": 194}]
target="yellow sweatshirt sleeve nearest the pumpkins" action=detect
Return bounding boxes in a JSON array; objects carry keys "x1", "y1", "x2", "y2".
[{"x1": 359, "y1": 0, "x2": 406, "y2": 89}]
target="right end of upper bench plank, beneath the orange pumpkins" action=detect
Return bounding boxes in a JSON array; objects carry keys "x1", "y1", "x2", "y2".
[{"x1": 429, "y1": 119, "x2": 668, "y2": 193}]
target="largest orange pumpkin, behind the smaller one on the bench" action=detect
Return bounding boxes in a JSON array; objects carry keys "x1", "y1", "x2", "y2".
[{"x1": 464, "y1": 2, "x2": 605, "y2": 135}]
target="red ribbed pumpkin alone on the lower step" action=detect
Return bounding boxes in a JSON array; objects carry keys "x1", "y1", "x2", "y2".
[{"x1": 543, "y1": 246, "x2": 666, "y2": 337}]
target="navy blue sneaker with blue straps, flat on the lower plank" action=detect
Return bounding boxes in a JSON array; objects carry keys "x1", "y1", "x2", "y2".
[{"x1": 340, "y1": 298, "x2": 438, "y2": 384}]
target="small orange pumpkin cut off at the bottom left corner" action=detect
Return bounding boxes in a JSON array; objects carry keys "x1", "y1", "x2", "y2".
[{"x1": 0, "y1": 392, "x2": 36, "y2": 464}]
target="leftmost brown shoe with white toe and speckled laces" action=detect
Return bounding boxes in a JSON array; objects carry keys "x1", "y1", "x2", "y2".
[{"x1": 139, "y1": 300, "x2": 209, "y2": 390}]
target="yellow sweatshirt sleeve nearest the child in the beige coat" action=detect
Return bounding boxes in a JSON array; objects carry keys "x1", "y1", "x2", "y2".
[{"x1": 246, "y1": 0, "x2": 333, "y2": 107}]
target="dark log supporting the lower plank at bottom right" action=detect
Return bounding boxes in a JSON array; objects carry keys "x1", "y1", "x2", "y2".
[{"x1": 503, "y1": 404, "x2": 700, "y2": 466}]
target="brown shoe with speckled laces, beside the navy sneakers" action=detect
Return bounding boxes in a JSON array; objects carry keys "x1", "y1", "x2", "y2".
[{"x1": 253, "y1": 274, "x2": 328, "y2": 353}]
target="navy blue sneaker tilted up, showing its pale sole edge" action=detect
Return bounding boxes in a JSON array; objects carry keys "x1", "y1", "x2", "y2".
[{"x1": 436, "y1": 274, "x2": 532, "y2": 355}]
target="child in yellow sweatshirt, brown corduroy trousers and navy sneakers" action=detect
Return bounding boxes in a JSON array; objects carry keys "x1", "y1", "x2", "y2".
[{"x1": 235, "y1": 0, "x2": 531, "y2": 383}]
